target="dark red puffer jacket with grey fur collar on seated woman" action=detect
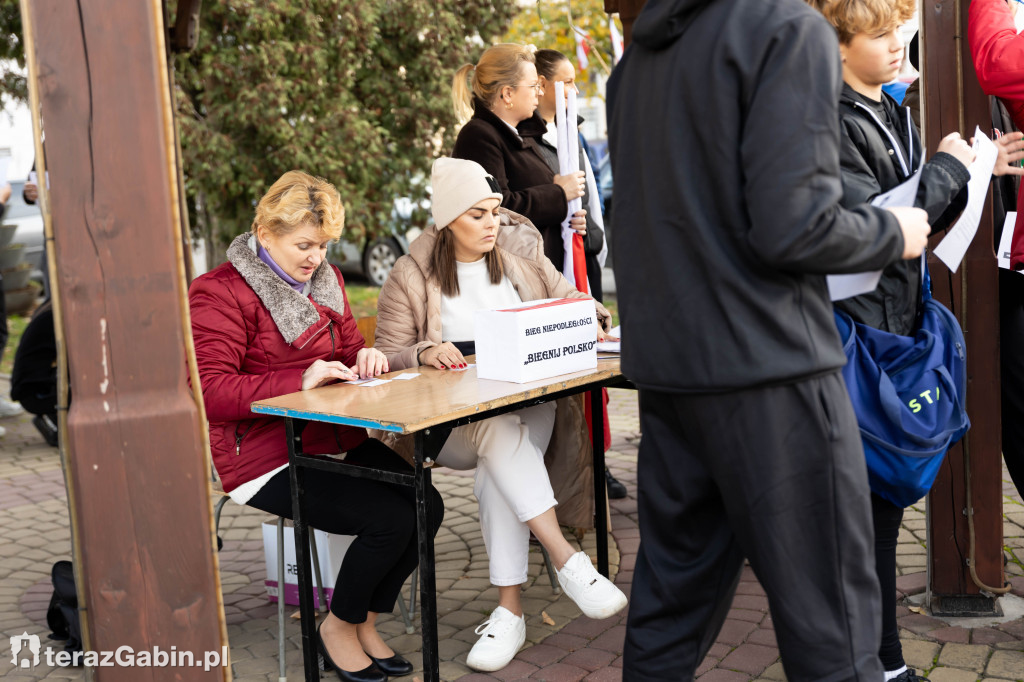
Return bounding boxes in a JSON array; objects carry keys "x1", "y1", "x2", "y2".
[{"x1": 188, "y1": 235, "x2": 367, "y2": 492}]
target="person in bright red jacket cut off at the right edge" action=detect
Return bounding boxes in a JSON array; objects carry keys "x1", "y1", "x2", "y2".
[{"x1": 968, "y1": 0, "x2": 1024, "y2": 495}]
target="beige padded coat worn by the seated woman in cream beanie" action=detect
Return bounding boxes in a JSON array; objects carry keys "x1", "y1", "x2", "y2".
[{"x1": 372, "y1": 209, "x2": 611, "y2": 528}]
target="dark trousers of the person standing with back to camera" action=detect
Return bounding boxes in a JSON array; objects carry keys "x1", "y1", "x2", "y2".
[{"x1": 623, "y1": 373, "x2": 882, "y2": 682}]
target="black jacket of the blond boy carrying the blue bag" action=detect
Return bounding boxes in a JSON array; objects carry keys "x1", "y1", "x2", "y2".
[{"x1": 837, "y1": 85, "x2": 971, "y2": 336}]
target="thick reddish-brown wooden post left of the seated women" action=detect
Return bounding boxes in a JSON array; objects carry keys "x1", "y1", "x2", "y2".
[{"x1": 22, "y1": 0, "x2": 230, "y2": 671}]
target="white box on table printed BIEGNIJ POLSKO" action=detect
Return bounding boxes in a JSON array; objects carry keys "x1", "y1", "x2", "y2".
[{"x1": 474, "y1": 298, "x2": 597, "y2": 384}]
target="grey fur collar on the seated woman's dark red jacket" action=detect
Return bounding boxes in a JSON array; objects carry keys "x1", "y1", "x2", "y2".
[{"x1": 227, "y1": 232, "x2": 345, "y2": 343}]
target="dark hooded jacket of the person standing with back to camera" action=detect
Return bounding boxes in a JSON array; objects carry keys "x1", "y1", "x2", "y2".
[{"x1": 608, "y1": 0, "x2": 903, "y2": 392}]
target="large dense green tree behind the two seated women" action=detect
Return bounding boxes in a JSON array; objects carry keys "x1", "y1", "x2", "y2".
[{"x1": 0, "y1": 0, "x2": 516, "y2": 260}]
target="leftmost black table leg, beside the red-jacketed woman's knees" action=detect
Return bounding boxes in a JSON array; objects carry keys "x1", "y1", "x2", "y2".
[{"x1": 286, "y1": 418, "x2": 319, "y2": 682}]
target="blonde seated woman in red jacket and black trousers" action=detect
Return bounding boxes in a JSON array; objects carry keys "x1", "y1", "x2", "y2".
[{"x1": 188, "y1": 171, "x2": 443, "y2": 682}]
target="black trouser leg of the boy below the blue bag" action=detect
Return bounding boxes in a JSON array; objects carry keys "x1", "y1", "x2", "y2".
[{"x1": 871, "y1": 493, "x2": 906, "y2": 671}]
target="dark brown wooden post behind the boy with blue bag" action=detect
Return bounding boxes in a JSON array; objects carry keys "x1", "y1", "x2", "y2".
[{"x1": 921, "y1": 0, "x2": 1004, "y2": 615}]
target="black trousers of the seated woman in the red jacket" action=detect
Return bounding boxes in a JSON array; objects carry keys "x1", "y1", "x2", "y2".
[{"x1": 249, "y1": 438, "x2": 444, "y2": 624}]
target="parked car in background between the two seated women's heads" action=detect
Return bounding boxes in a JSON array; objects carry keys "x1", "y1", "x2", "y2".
[{"x1": 328, "y1": 197, "x2": 430, "y2": 287}]
